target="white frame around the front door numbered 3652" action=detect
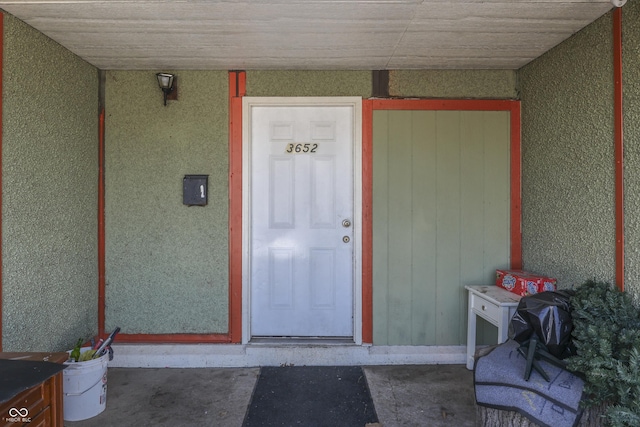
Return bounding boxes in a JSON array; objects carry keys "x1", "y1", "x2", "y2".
[{"x1": 242, "y1": 97, "x2": 363, "y2": 345}]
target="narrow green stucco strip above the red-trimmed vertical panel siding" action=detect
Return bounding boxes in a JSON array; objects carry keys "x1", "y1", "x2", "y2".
[{"x1": 389, "y1": 70, "x2": 518, "y2": 99}]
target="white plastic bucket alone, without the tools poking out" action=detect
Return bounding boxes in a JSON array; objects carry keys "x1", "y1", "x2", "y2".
[{"x1": 62, "y1": 347, "x2": 109, "y2": 421}]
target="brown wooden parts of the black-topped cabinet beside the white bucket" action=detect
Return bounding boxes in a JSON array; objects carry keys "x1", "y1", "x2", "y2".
[{"x1": 0, "y1": 353, "x2": 68, "y2": 427}]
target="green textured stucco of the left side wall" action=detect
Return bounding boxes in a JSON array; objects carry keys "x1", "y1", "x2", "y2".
[{"x1": 2, "y1": 14, "x2": 98, "y2": 351}]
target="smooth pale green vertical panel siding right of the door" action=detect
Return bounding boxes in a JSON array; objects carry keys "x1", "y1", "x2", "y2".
[{"x1": 373, "y1": 111, "x2": 510, "y2": 345}]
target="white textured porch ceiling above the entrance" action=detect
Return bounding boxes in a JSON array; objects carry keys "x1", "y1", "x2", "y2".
[{"x1": 0, "y1": 0, "x2": 612, "y2": 70}]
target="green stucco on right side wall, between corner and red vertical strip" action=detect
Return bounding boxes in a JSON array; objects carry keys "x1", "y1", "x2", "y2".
[{"x1": 519, "y1": 14, "x2": 615, "y2": 287}]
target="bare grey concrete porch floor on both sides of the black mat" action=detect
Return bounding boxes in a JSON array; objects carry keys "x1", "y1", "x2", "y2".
[{"x1": 65, "y1": 365, "x2": 476, "y2": 427}]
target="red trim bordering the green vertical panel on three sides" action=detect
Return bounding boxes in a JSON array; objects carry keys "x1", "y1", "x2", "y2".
[{"x1": 362, "y1": 99, "x2": 522, "y2": 343}]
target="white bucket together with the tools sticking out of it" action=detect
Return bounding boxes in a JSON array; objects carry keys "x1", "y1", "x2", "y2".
[{"x1": 63, "y1": 328, "x2": 120, "y2": 421}]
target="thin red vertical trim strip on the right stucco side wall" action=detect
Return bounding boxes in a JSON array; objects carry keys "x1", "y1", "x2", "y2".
[{"x1": 613, "y1": 7, "x2": 624, "y2": 291}]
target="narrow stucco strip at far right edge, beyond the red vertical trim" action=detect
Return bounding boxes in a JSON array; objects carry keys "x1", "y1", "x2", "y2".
[{"x1": 622, "y1": 0, "x2": 640, "y2": 301}]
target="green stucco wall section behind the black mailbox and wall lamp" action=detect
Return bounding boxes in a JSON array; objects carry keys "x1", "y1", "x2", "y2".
[{"x1": 105, "y1": 71, "x2": 229, "y2": 334}]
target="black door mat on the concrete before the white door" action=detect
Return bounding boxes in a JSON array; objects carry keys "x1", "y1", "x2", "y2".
[{"x1": 243, "y1": 366, "x2": 378, "y2": 427}]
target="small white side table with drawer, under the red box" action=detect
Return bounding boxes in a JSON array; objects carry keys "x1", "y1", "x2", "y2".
[{"x1": 464, "y1": 285, "x2": 522, "y2": 369}]
